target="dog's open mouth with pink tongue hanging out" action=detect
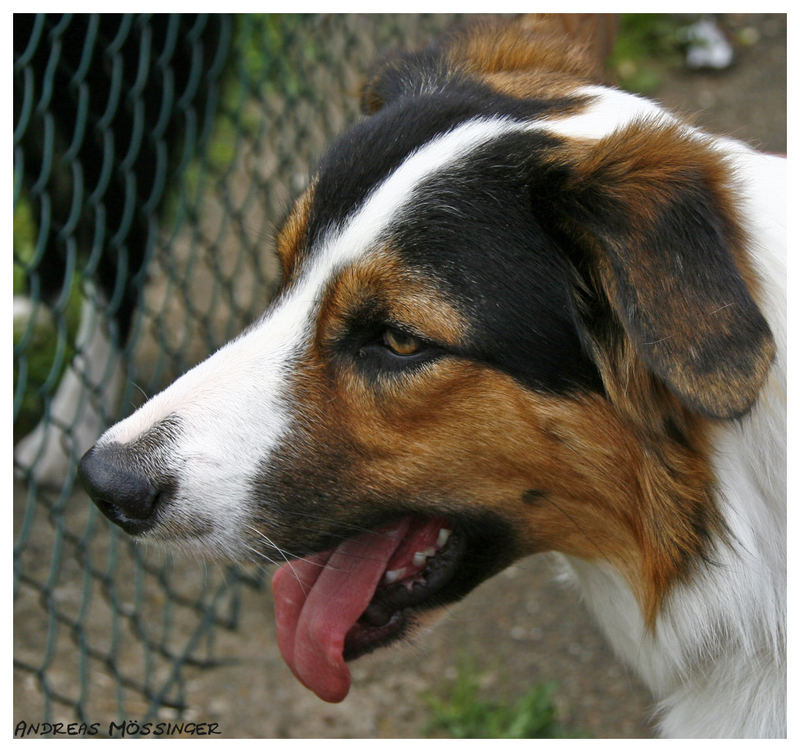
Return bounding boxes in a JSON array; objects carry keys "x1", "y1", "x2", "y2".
[{"x1": 273, "y1": 517, "x2": 485, "y2": 702}]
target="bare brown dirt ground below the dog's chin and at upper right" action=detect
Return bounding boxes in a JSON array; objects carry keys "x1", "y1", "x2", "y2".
[{"x1": 15, "y1": 15, "x2": 787, "y2": 738}]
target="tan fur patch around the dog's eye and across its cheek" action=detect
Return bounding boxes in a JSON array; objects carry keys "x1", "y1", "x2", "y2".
[{"x1": 260, "y1": 247, "x2": 719, "y2": 623}]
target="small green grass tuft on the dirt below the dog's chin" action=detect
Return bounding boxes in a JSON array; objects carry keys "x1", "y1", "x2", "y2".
[{"x1": 423, "y1": 659, "x2": 577, "y2": 739}]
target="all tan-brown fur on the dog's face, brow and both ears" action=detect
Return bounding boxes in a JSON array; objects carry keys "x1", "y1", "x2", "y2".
[{"x1": 266, "y1": 16, "x2": 774, "y2": 626}]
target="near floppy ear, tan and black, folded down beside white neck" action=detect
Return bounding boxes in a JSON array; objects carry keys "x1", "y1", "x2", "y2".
[{"x1": 557, "y1": 123, "x2": 775, "y2": 418}]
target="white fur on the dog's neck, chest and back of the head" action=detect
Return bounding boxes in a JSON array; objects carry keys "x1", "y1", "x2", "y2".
[{"x1": 548, "y1": 90, "x2": 786, "y2": 737}]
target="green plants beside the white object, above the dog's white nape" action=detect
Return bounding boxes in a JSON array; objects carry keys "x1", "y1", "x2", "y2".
[{"x1": 609, "y1": 13, "x2": 688, "y2": 94}]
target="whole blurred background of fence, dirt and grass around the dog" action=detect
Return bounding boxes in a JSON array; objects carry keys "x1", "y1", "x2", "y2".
[{"x1": 13, "y1": 14, "x2": 786, "y2": 737}]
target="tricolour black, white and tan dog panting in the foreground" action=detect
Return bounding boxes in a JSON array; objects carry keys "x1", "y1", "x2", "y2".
[{"x1": 80, "y1": 16, "x2": 786, "y2": 737}]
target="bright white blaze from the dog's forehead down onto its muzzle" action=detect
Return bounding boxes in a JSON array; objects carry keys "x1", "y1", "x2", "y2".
[{"x1": 102, "y1": 117, "x2": 531, "y2": 452}]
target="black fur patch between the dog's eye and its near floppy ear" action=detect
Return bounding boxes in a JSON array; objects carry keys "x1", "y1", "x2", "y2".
[{"x1": 391, "y1": 134, "x2": 602, "y2": 392}]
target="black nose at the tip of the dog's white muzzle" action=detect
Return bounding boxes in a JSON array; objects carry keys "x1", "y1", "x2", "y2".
[{"x1": 78, "y1": 444, "x2": 158, "y2": 535}]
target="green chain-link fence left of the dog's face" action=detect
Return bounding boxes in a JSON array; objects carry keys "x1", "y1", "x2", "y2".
[{"x1": 13, "y1": 14, "x2": 452, "y2": 735}]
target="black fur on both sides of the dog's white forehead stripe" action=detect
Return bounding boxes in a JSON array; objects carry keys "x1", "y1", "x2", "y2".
[{"x1": 294, "y1": 49, "x2": 602, "y2": 392}]
